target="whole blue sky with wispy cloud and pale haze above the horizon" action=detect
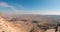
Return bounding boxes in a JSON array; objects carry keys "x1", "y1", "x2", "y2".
[{"x1": 0, "y1": 0, "x2": 60, "y2": 15}]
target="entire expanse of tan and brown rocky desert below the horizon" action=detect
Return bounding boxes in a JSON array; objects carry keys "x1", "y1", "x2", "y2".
[{"x1": 0, "y1": 15, "x2": 60, "y2": 32}]
